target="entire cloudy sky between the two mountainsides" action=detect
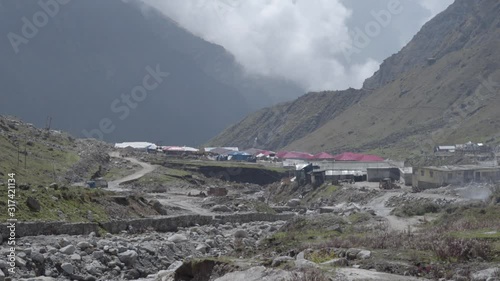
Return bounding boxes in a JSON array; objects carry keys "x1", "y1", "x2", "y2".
[{"x1": 142, "y1": 0, "x2": 453, "y2": 90}]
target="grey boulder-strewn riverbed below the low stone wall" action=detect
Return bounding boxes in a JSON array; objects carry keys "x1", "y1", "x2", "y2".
[{"x1": 0, "y1": 221, "x2": 285, "y2": 280}]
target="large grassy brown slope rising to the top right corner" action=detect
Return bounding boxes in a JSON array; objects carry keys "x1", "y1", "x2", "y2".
[{"x1": 212, "y1": 0, "x2": 500, "y2": 156}]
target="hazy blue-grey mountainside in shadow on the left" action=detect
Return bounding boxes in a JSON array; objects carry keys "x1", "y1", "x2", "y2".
[{"x1": 0, "y1": 0, "x2": 299, "y2": 145}]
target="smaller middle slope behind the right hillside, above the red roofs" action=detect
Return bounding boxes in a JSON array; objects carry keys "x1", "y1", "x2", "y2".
[{"x1": 210, "y1": 89, "x2": 366, "y2": 149}]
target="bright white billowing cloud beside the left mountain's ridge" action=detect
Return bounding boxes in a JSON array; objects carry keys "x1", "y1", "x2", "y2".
[{"x1": 137, "y1": 0, "x2": 378, "y2": 90}]
